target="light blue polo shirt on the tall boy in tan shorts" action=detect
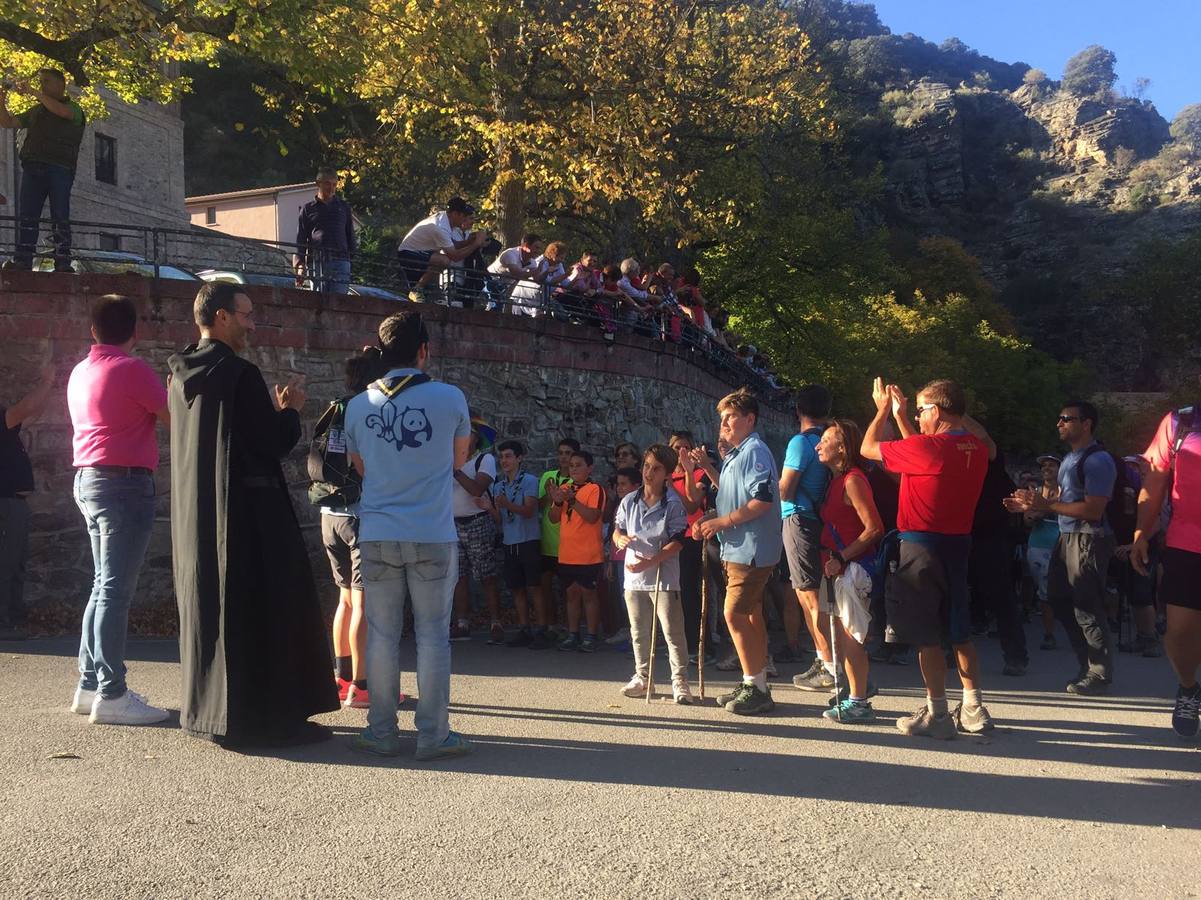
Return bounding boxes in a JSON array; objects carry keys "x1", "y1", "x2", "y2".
[{"x1": 717, "y1": 431, "x2": 784, "y2": 567}]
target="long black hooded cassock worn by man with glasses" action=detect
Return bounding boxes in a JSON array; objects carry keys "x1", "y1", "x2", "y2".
[{"x1": 168, "y1": 339, "x2": 339, "y2": 744}]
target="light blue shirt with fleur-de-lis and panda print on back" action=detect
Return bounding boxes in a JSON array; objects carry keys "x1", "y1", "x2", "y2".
[{"x1": 346, "y1": 369, "x2": 471, "y2": 543}]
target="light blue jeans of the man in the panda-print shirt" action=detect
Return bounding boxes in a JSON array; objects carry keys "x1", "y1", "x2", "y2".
[{"x1": 359, "y1": 541, "x2": 459, "y2": 751}]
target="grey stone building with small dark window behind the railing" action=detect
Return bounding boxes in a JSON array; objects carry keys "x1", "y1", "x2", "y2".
[{"x1": 0, "y1": 90, "x2": 189, "y2": 252}]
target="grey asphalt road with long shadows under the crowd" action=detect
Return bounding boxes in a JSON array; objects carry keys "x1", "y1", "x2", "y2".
[{"x1": 0, "y1": 633, "x2": 1201, "y2": 900}]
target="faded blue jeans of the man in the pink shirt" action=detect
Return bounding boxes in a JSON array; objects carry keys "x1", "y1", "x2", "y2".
[{"x1": 74, "y1": 469, "x2": 154, "y2": 699}]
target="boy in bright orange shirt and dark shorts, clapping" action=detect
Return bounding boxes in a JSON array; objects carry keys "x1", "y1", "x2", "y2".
[{"x1": 546, "y1": 451, "x2": 605, "y2": 654}]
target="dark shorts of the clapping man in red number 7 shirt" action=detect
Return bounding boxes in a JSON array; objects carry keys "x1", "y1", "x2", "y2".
[{"x1": 884, "y1": 535, "x2": 972, "y2": 646}]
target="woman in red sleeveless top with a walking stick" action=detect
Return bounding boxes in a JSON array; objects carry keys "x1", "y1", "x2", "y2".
[{"x1": 817, "y1": 419, "x2": 884, "y2": 723}]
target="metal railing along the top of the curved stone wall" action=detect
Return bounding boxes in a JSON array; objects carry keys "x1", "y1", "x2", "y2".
[{"x1": 0, "y1": 216, "x2": 784, "y2": 409}]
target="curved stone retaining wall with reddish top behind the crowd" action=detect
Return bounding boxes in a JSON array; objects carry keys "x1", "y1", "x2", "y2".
[{"x1": 0, "y1": 272, "x2": 793, "y2": 633}]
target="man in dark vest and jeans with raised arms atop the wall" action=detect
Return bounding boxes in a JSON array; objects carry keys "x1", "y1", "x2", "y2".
[{"x1": 0, "y1": 68, "x2": 88, "y2": 272}]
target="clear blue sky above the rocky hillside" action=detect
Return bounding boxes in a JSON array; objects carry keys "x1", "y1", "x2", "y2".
[{"x1": 859, "y1": 0, "x2": 1201, "y2": 120}]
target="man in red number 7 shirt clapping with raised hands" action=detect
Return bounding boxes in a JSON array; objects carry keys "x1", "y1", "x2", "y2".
[{"x1": 862, "y1": 379, "x2": 997, "y2": 740}]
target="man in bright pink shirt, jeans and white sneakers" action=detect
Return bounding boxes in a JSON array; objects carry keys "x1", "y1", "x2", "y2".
[{"x1": 67, "y1": 294, "x2": 169, "y2": 725}]
